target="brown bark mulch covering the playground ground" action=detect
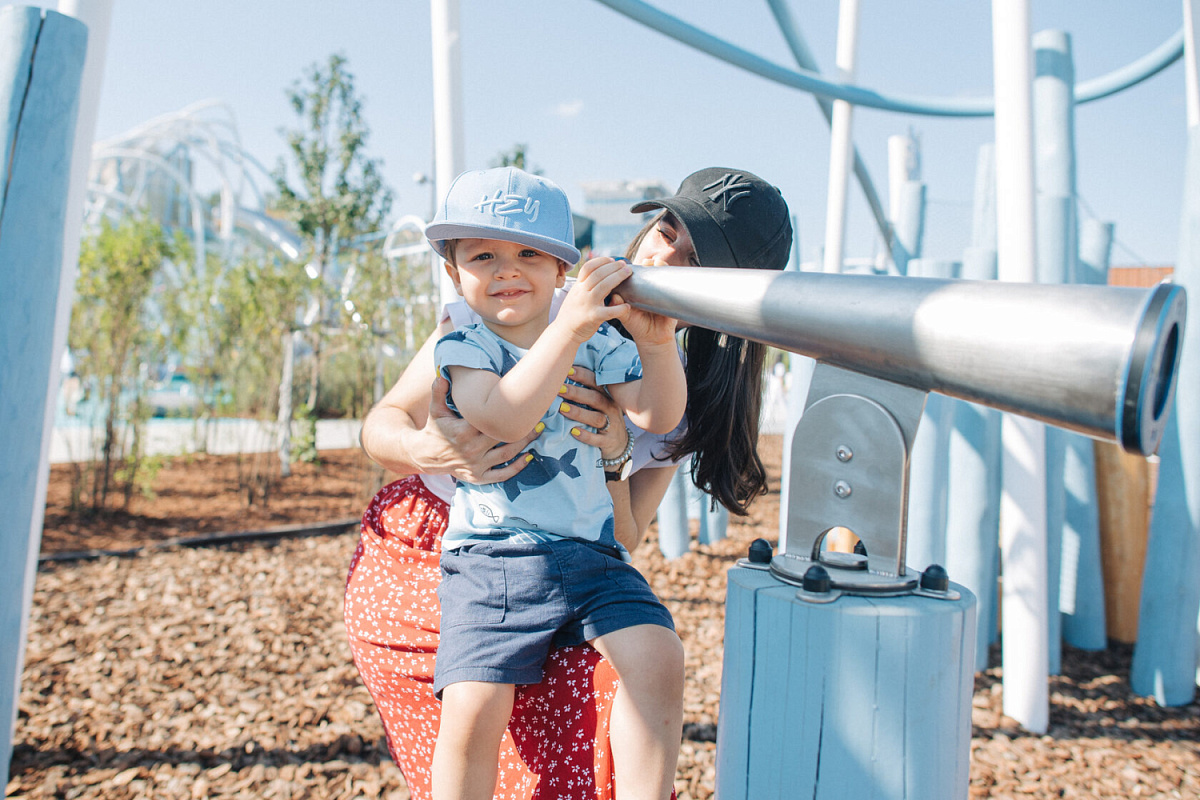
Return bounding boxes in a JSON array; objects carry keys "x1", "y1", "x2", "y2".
[{"x1": 6, "y1": 437, "x2": 1200, "y2": 800}]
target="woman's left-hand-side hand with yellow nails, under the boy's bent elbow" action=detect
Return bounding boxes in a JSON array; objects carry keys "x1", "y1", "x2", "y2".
[{"x1": 421, "y1": 377, "x2": 541, "y2": 483}]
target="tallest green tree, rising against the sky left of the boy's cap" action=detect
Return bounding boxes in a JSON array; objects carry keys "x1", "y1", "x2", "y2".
[{"x1": 274, "y1": 54, "x2": 391, "y2": 408}]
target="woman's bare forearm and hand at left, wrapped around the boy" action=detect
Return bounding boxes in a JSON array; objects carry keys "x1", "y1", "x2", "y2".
[{"x1": 359, "y1": 324, "x2": 536, "y2": 483}]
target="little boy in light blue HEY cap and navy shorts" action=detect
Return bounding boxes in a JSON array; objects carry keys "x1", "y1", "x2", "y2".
[{"x1": 425, "y1": 167, "x2": 686, "y2": 800}]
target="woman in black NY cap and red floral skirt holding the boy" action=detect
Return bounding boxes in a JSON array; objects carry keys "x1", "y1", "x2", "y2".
[{"x1": 344, "y1": 168, "x2": 792, "y2": 800}]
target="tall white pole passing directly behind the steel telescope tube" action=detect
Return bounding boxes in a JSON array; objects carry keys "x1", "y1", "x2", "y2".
[{"x1": 991, "y1": 0, "x2": 1050, "y2": 733}]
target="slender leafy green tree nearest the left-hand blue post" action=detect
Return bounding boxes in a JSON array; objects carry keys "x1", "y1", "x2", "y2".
[{"x1": 70, "y1": 216, "x2": 178, "y2": 510}]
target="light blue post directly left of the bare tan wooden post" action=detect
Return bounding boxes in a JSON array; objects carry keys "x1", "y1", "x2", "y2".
[{"x1": 1060, "y1": 219, "x2": 1112, "y2": 650}]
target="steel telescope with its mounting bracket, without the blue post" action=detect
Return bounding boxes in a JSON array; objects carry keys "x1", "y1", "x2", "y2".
[{"x1": 617, "y1": 267, "x2": 1187, "y2": 592}]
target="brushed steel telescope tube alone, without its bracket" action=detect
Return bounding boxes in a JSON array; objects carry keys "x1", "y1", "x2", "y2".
[{"x1": 617, "y1": 266, "x2": 1187, "y2": 455}]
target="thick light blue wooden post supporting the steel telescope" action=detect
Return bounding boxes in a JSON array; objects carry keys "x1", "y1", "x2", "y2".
[{"x1": 716, "y1": 566, "x2": 976, "y2": 800}]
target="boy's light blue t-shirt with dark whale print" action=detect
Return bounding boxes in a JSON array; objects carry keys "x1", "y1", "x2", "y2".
[{"x1": 433, "y1": 323, "x2": 642, "y2": 549}]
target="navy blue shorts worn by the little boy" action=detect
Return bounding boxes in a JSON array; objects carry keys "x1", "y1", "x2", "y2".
[{"x1": 433, "y1": 540, "x2": 674, "y2": 697}]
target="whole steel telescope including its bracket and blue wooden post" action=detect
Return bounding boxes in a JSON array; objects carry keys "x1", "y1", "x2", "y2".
[{"x1": 622, "y1": 267, "x2": 1186, "y2": 800}]
